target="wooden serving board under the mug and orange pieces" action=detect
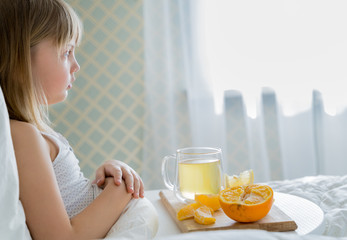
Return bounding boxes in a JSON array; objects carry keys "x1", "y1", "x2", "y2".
[{"x1": 159, "y1": 190, "x2": 297, "y2": 232}]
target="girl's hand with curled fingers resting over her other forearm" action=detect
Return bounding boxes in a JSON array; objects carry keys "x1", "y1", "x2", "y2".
[{"x1": 93, "y1": 160, "x2": 144, "y2": 198}]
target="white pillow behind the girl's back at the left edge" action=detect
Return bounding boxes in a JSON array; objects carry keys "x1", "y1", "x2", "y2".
[{"x1": 0, "y1": 88, "x2": 31, "y2": 239}]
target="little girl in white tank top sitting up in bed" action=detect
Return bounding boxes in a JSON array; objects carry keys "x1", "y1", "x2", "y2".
[{"x1": 0, "y1": 0, "x2": 156, "y2": 240}]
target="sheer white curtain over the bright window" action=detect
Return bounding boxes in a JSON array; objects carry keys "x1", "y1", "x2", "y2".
[{"x1": 141, "y1": 0, "x2": 347, "y2": 189}]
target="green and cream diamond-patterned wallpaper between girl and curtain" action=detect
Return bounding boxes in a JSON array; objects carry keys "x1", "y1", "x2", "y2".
[{"x1": 50, "y1": 0, "x2": 145, "y2": 178}]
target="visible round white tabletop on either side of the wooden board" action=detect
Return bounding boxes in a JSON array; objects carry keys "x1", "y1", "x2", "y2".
[{"x1": 145, "y1": 190, "x2": 324, "y2": 237}]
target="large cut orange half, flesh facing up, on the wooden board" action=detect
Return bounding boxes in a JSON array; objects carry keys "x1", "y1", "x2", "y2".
[{"x1": 219, "y1": 184, "x2": 274, "y2": 222}]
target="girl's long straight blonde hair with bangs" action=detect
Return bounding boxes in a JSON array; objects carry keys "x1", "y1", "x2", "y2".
[{"x1": 0, "y1": 0, "x2": 82, "y2": 131}]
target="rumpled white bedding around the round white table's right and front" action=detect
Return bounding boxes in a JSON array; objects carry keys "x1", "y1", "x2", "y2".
[{"x1": 159, "y1": 175, "x2": 347, "y2": 240}]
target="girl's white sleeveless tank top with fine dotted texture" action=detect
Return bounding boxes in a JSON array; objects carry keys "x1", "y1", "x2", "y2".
[{"x1": 42, "y1": 133, "x2": 102, "y2": 218}]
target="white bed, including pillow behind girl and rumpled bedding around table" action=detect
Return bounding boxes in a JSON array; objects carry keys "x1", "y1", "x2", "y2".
[{"x1": 0, "y1": 85, "x2": 347, "y2": 240}]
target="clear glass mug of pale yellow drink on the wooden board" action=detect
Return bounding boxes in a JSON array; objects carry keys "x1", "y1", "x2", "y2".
[{"x1": 161, "y1": 147, "x2": 224, "y2": 202}]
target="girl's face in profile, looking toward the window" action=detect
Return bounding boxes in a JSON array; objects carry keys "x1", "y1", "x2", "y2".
[{"x1": 31, "y1": 40, "x2": 80, "y2": 105}]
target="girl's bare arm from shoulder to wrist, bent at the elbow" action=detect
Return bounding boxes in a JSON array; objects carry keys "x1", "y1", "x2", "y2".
[{"x1": 11, "y1": 121, "x2": 131, "y2": 240}]
